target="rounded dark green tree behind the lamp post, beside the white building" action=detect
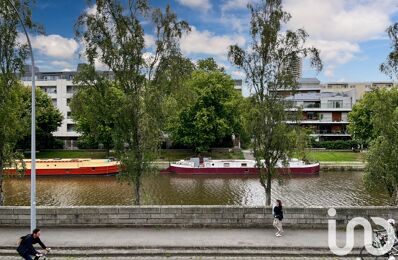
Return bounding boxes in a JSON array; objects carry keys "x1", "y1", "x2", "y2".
[{"x1": 17, "y1": 87, "x2": 63, "y2": 150}]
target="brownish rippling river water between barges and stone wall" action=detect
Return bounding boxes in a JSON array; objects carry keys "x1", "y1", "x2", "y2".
[{"x1": 4, "y1": 172, "x2": 388, "y2": 206}]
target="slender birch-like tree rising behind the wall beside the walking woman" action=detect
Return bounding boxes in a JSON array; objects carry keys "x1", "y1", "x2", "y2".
[{"x1": 228, "y1": 0, "x2": 322, "y2": 205}]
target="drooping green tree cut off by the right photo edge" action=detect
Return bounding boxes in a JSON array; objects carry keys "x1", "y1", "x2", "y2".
[{"x1": 359, "y1": 23, "x2": 398, "y2": 205}]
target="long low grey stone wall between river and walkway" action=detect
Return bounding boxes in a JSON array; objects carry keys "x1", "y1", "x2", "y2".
[{"x1": 0, "y1": 206, "x2": 398, "y2": 228}]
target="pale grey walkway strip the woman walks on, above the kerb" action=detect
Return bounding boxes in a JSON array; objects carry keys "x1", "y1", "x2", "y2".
[{"x1": 0, "y1": 227, "x2": 363, "y2": 248}]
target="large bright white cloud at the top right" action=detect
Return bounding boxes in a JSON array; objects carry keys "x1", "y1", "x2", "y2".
[{"x1": 285, "y1": 0, "x2": 398, "y2": 41}]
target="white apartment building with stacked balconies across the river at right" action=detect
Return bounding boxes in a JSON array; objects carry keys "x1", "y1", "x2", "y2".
[{"x1": 282, "y1": 78, "x2": 397, "y2": 141}]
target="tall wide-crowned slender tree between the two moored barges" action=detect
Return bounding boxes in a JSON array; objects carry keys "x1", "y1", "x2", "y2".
[{"x1": 76, "y1": 0, "x2": 189, "y2": 205}]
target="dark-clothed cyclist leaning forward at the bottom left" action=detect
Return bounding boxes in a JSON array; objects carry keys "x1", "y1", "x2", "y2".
[{"x1": 17, "y1": 228, "x2": 50, "y2": 260}]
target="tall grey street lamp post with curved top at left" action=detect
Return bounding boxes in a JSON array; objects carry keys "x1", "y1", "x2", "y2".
[{"x1": 7, "y1": 0, "x2": 36, "y2": 231}]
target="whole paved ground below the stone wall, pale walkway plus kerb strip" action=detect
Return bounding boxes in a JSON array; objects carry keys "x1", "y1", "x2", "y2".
[{"x1": 0, "y1": 227, "x2": 363, "y2": 260}]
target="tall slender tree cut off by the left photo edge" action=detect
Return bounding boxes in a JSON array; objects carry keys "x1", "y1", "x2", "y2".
[{"x1": 0, "y1": 0, "x2": 35, "y2": 206}]
